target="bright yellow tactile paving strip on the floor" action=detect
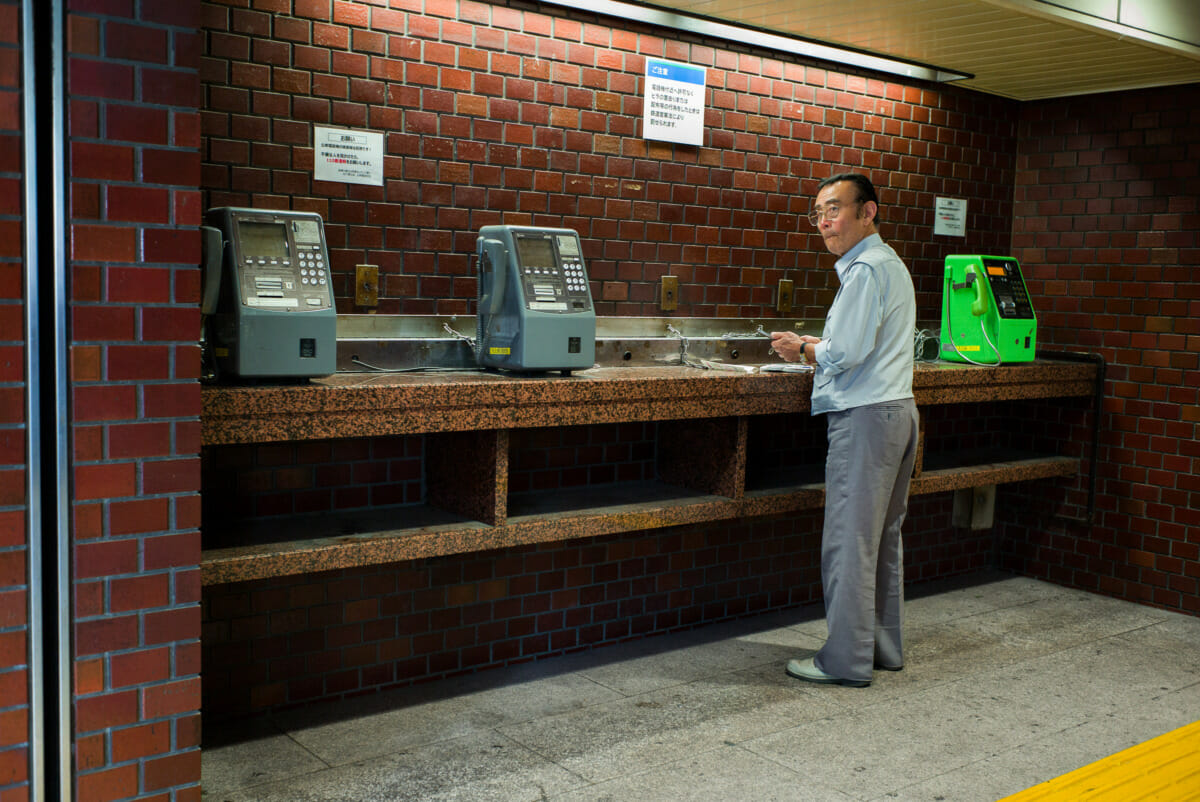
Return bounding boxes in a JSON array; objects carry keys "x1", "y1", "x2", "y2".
[{"x1": 1000, "y1": 722, "x2": 1200, "y2": 802}]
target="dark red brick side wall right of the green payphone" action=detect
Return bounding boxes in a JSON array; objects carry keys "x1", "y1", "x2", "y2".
[{"x1": 1004, "y1": 84, "x2": 1200, "y2": 614}]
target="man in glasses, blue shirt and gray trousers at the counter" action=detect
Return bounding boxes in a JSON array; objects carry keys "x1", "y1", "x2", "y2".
[{"x1": 770, "y1": 173, "x2": 917, "y2": 687}]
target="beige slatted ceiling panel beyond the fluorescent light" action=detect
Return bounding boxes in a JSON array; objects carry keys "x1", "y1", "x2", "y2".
[{"x1": 643, "y1": 0, "x2": 1200, "y2": 100}]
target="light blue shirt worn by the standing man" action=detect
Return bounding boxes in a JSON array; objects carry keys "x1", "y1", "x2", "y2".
[{"x1": 812, "y1": 234, "x2": 917, "y2": 415}]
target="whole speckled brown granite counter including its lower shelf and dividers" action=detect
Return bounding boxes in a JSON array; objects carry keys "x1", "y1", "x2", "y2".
[{"x1": 202, "y1": 360, "x2": 1097, "y2": 585}]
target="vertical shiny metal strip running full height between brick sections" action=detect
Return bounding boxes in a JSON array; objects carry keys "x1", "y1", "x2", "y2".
[{"x1": 20, "y1": 0, "x2": 74, "y2": 802}]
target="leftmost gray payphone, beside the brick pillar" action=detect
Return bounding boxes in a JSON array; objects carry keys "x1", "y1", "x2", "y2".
[{"x1": 202, "y1": 207, "x2": 337, "y2": 378}]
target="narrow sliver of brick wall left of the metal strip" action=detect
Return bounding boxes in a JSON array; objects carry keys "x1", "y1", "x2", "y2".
[{"x1": 0, "y1": 0, "x2": 31, "y2": 802}]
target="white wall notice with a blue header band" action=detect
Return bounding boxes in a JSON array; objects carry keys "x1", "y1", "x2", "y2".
[{"x1": 642, "y1": 59, "x2": 707, "y2": 145}]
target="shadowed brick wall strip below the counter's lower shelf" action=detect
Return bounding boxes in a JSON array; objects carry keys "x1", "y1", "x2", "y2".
[{"x1": 204, "y1": 496, "x2": 994, "y2": 719}]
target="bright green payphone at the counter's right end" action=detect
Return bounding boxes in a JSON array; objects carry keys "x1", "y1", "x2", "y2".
[{"x1": 941, "y1": 255, "x2": 1038, "y2": 365}]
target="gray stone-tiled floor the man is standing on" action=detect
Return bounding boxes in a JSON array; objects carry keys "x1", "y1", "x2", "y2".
[{"x1": 203, "y1": 575, "x2": 1200, "y2": 802}]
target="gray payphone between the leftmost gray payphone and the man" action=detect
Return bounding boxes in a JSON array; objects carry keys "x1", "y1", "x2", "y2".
[{"x1": 475, "y1": 226, "x2": 596, "y2": 372}]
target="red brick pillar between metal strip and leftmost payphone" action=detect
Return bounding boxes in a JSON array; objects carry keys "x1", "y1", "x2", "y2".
[{"x1": 67, "y1": 0, "x2": 202, "y2": 801}]
